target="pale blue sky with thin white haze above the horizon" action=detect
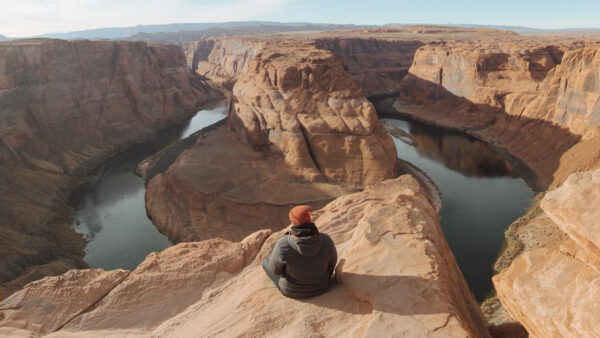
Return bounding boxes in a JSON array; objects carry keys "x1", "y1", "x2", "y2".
[{"x1": 0, "y1": 0, "x2": 600, "y2": 37}]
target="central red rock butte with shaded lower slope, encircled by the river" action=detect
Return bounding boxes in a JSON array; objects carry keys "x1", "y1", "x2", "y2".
[{"x1": 140, "y1": 42, "x2": 398, "y2": 241}]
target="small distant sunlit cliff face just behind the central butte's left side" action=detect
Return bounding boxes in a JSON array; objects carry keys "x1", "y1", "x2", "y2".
[{"x1": 182, "y1": 38, "x2": 264, "y2": 89}]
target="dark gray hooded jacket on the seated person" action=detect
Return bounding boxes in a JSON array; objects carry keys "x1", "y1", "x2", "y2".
[{"x1": 269, "y1": 230, "x2": 337, "y2": 298}]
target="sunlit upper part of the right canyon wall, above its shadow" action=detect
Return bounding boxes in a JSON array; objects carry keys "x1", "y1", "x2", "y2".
[{"x1": 410, "y1": 42, "x2": 600, "y2": 139}]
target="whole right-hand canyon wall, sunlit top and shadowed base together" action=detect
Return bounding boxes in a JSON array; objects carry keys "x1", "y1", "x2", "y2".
[{"x1": 396, "y1": 40, "x2": 600, "y2": 189}]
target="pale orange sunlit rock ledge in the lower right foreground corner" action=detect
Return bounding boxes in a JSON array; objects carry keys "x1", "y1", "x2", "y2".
[{"x1": 494, "y1": 170, "x2": 600, "y2": 337}]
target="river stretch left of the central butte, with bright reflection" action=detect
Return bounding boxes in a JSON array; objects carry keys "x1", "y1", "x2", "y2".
[{"x1": 71, "y1": 104, "x2": 228, "y2": 270}]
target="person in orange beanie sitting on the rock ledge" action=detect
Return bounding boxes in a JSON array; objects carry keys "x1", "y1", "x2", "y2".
[{"x1": 262, "y1": 205, "x2": 337, "y2": 298}]
